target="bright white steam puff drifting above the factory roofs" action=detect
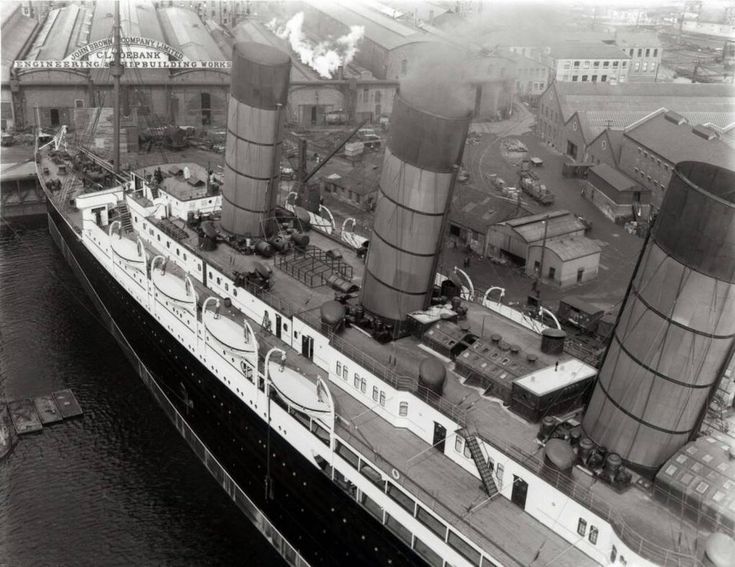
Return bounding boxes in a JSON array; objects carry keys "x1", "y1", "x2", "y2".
[{"x1": 266, "y1": 12, "x2": 365, "y2": 79}]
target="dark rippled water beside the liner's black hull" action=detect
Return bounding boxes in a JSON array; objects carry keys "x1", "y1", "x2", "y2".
[{"x1": 0, "y1": 220, "x2": 283, "y2": 567}]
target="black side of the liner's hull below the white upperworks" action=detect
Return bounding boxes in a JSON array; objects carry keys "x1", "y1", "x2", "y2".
[{"x1": 47, "y1": 199, "x2": 423, "y2": 565}]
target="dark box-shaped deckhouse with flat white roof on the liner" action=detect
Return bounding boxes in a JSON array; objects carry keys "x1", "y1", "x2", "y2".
[{"x1": 510, "y1": 359, "x2": 597, "y2": 422}]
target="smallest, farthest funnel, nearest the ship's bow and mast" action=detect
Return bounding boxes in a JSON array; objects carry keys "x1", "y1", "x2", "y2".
[{"x1": 222, "y1": 42, "x2": 291, "y2": 236}]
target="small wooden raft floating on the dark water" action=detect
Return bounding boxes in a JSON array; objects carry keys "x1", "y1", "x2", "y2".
[{"x1": 0, "y1": 389, "x2": 83, "y2": 457}]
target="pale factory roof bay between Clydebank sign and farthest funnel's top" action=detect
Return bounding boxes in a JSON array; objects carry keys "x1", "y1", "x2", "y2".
[{"x1": 158, "y1": 7, "x2": 225, "y2": 61}]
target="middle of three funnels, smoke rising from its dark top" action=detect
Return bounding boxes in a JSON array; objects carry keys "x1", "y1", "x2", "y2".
[{"x1": 362, "y1": 93, "x2": 470, "y2": 323}]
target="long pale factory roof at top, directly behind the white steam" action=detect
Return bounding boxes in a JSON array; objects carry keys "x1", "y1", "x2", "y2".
[{"x1": 307, "y1": 0, "x2": 439, "y2": 50}]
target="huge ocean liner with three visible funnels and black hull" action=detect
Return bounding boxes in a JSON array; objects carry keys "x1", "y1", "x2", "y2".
[{"x1": 36, "y1": 5, "x2": 735, "y2": 567}]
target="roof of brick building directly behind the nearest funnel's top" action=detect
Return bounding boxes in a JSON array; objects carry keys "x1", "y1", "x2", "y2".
[{"x1": 625, "y1": 114, "x2": 735, "y2": 167}]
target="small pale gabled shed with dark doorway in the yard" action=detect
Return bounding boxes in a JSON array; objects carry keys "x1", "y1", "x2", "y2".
[{"x1": 526, "y1": 236, "x2": 602, "y2": 287}]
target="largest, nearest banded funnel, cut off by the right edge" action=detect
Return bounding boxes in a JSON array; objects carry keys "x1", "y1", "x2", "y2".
[{"x1": 583, "y1": 162, "x2": 735, "y2": 474}]
